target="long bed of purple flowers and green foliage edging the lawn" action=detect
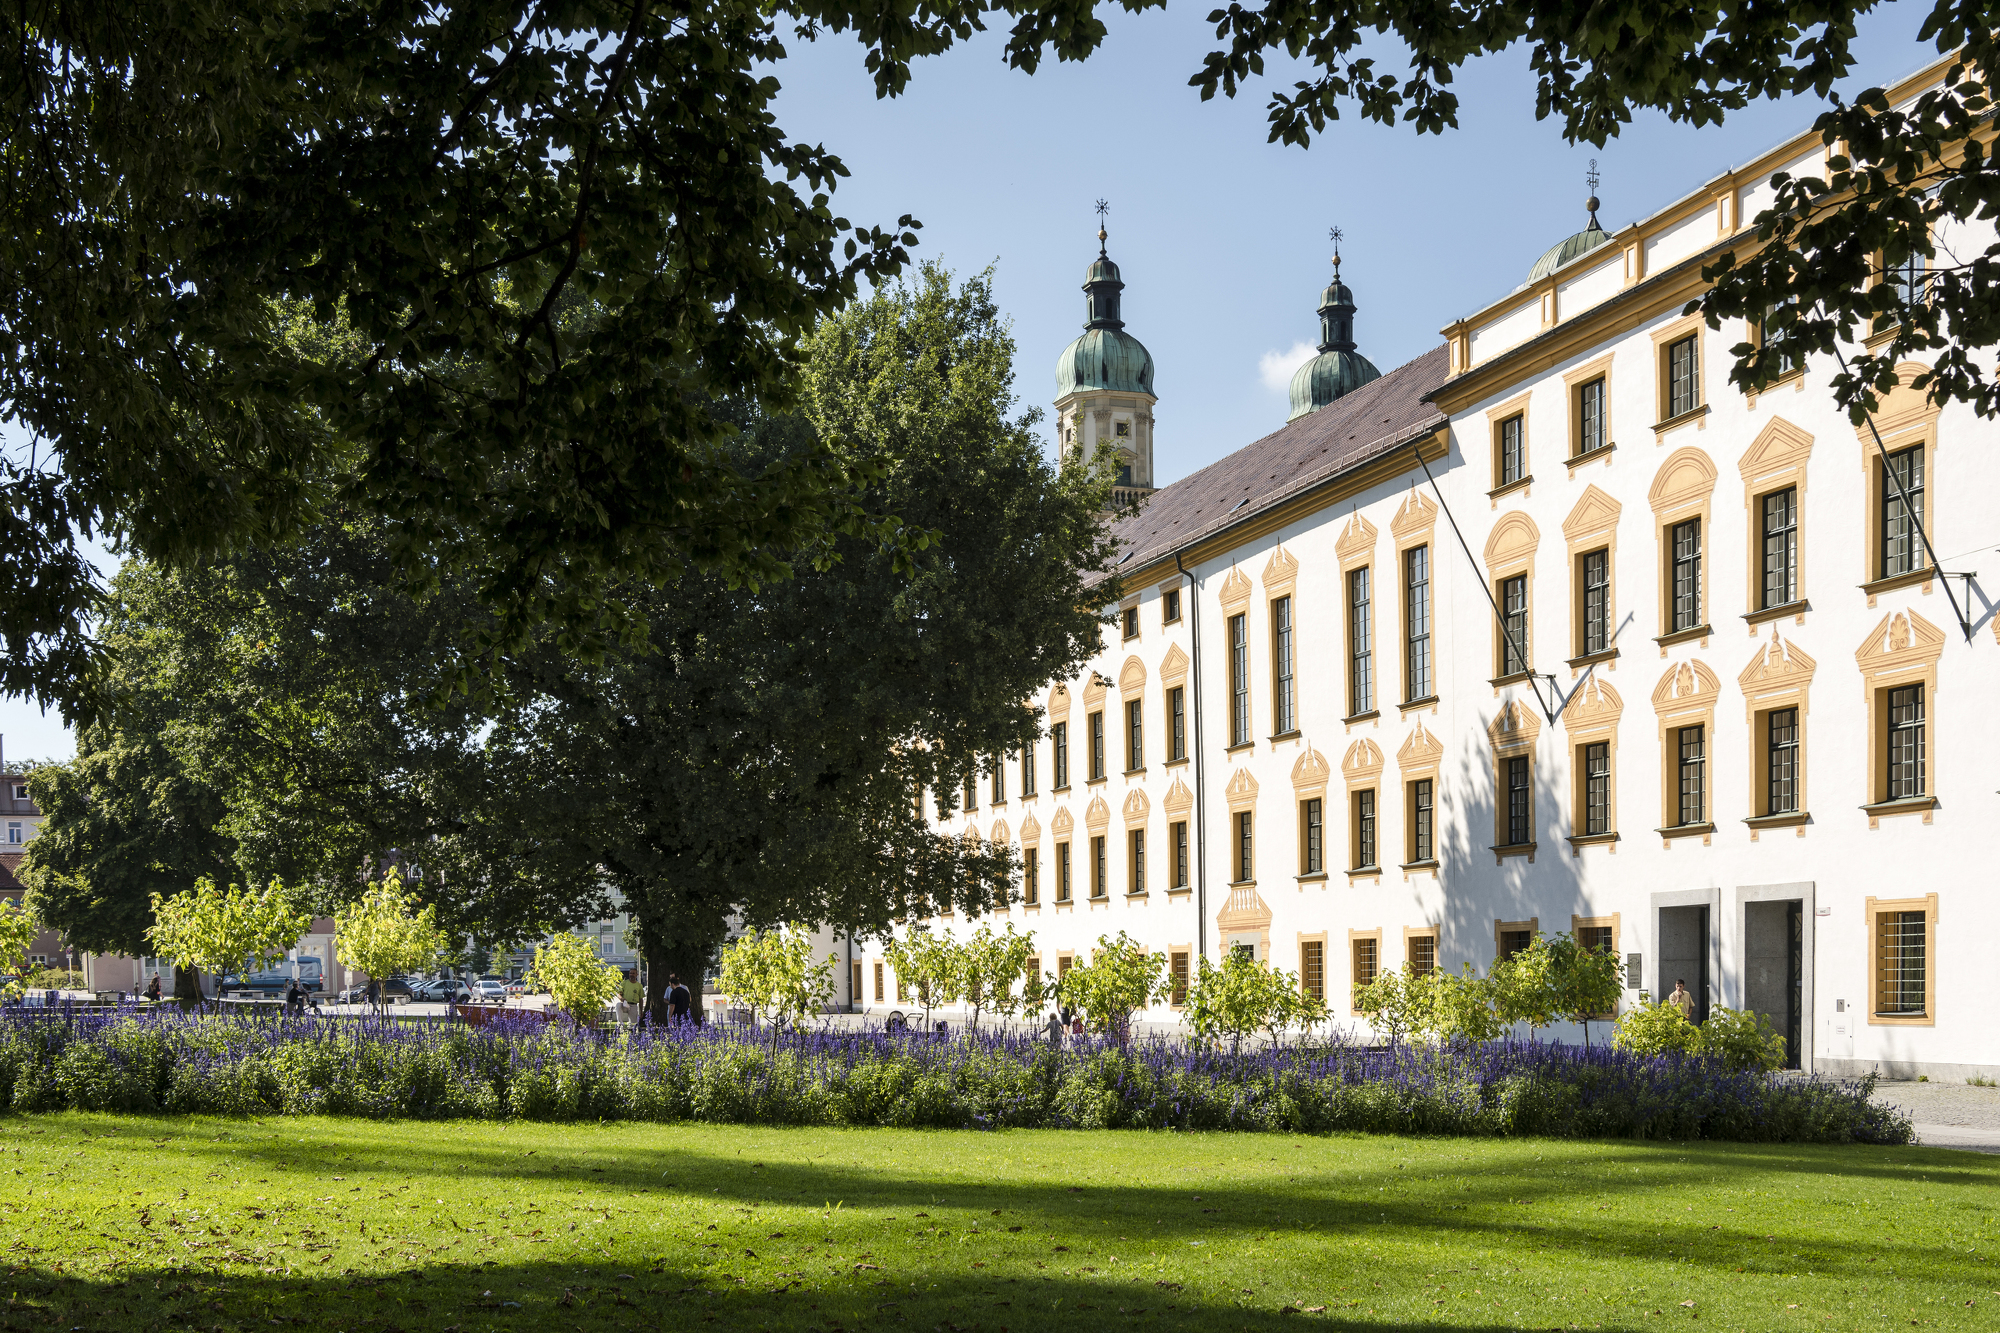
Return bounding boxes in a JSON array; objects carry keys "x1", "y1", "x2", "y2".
[{"x1": 0, "y1": 1009, "x2": 1912, "y2": 1143}]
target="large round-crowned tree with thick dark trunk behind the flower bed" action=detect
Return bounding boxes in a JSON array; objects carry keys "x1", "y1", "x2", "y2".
[{"x1": 486, "y1": 268, "x2": 1112, "y2": 1011}]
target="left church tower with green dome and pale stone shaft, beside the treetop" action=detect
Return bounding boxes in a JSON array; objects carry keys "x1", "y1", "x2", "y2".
[{"x1": 1056, "y1": 210, "x2": 1158, "y2": 508}]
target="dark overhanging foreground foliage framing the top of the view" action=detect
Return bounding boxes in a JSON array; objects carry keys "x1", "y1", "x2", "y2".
[{"x1": 11, "y1": 0, "x2": 2000, "y2": 709}]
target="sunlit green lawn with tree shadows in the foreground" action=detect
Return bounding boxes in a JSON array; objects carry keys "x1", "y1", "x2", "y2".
[{"x1": 0, "y1": 1115, "x2": 2000, "y2": 1333}]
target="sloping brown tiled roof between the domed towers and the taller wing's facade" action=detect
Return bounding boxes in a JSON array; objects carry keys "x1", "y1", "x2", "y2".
[{"x1": 1112, "y1": 346, "x2": 1450, "y2": 568}]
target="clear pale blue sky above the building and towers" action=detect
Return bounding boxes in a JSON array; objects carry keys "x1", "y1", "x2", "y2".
[{"x1": 0, "y1": 0, "x2": 1932, "y2": 759}]
